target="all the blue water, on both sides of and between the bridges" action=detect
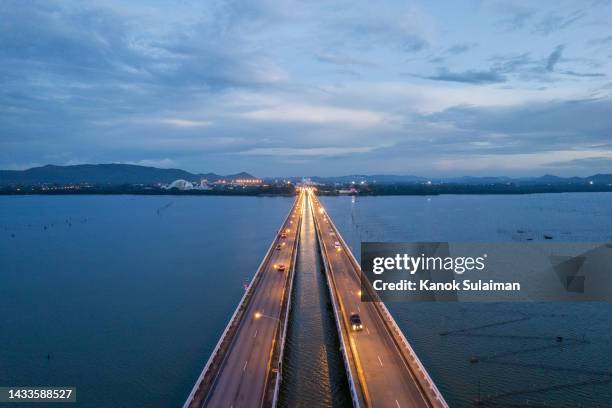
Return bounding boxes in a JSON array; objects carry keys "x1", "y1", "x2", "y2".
[{"x1": 0, "y1": 193, "x2": 612, "y2": 407}]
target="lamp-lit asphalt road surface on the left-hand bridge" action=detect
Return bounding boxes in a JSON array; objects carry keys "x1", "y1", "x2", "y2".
[{"x1": 185, "y1": 194, "x2": 305, "y2": 408}]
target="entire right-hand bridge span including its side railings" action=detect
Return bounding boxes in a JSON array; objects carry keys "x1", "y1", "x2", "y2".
[{"x1": 307, "y1": 189, "x2": 448, "y2": 408}]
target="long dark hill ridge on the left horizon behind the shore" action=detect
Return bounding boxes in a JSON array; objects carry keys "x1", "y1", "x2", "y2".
[{"x1": 0, "y1": 164, "x2": 254, "y2": 186}]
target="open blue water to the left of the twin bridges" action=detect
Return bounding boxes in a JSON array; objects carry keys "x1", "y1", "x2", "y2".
[{"x1": 0, "y1": 196, "x2": 293, "y2": 407}]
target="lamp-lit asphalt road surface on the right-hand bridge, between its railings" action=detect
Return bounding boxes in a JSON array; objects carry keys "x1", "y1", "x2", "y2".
[{"x1": 308, "y1": 193, "x2": 446, "y2": 408}]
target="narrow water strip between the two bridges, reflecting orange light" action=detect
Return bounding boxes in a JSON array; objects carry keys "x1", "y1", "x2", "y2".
[{"x1": 279, "y1": 194, "x2": 352, "y2": 408}]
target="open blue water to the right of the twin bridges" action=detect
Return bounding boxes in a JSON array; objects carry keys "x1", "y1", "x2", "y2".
[{"x1": 321, "y1": 193, "x2": 612, "y2": 407}]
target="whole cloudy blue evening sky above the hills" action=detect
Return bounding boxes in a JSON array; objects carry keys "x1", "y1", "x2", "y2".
[{"x1": 0, "y1": 0, "x2": 612, "y2": 176}]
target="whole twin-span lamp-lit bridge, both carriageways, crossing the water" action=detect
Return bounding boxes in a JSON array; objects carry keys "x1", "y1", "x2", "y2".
[{"x1": 183, "y1": 188, "x2": 448, "y2": 408}]
